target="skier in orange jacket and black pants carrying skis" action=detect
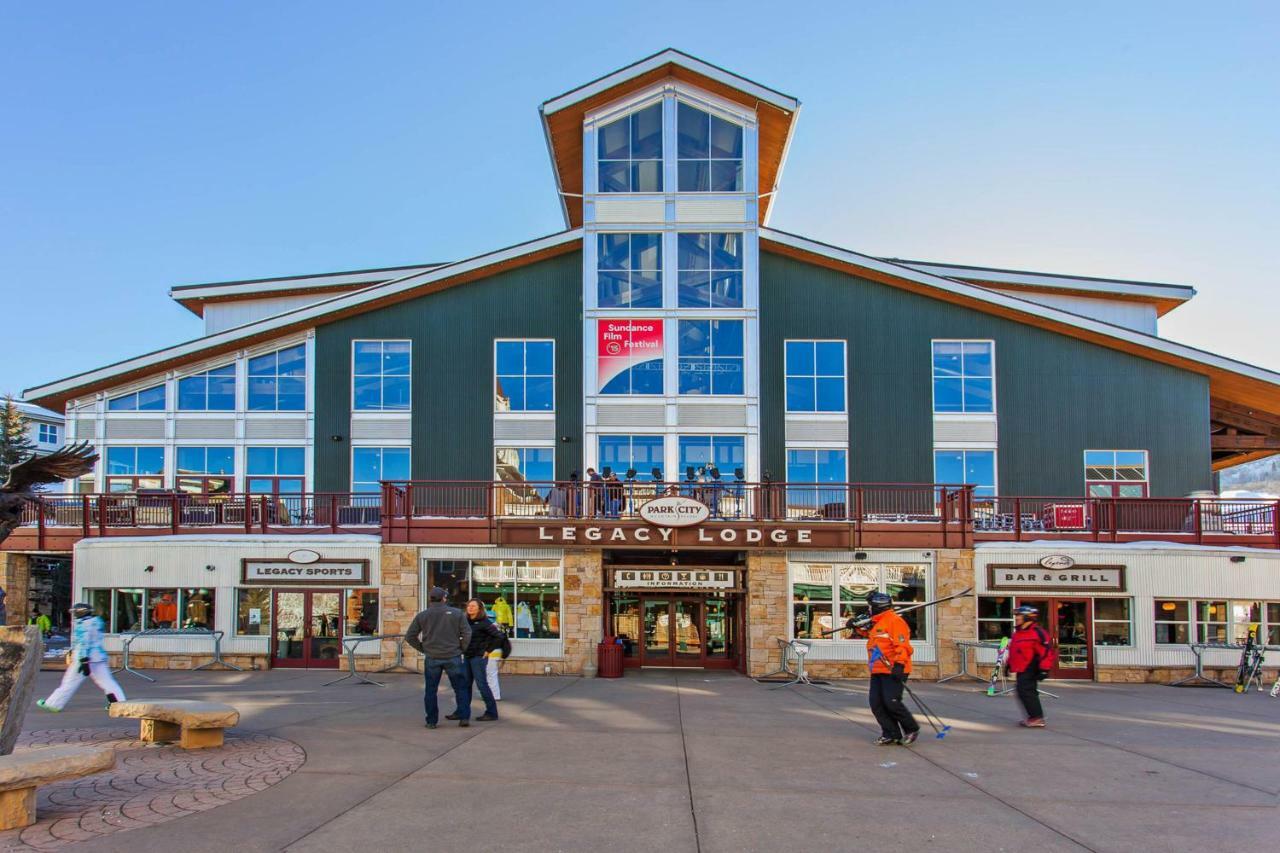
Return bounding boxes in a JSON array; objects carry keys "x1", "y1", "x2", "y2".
[{"x1": 845, "y1": 592, "x2": 920, "y2": 747}]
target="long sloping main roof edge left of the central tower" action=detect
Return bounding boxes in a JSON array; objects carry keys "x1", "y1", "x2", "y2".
[{"x1": 24, "y1": 231, "x2": 582, "y2": 410}]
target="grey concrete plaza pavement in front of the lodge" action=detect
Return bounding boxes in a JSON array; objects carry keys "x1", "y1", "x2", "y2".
[{"x1": 0, "y1": 670, "x2": 1280, "y2": 853}]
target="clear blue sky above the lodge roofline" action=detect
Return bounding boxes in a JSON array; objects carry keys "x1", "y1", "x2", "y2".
[{"x1": 0, "y1": 0, "x2": 1280, "y2": 392}]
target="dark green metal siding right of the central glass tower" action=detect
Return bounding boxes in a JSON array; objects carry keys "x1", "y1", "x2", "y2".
[{"x1": 760, "y1": 254, "x2": 1211, "y2": 497}]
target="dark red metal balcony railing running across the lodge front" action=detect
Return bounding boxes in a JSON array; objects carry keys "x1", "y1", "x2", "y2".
[{"x1": 8, "y1": 480, "x2": 1280, "y2": 549}]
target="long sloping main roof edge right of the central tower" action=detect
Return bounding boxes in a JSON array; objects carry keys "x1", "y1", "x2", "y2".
[{"x1": 760, "y1": 228, "x2": 1280, "y2": 412}]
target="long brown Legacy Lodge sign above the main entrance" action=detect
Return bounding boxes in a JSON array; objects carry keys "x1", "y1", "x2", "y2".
[{"x1": 498, "y1": 517, "x2": 851, "y2": 551}]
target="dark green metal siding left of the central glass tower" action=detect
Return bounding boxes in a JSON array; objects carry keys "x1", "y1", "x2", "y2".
[{"x1": 315, "y1": 251, "x2": 582, "y2": 492}]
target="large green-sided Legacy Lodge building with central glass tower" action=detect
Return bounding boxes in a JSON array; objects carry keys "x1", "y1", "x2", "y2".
[{"x1": 0, "y1": 50, "x2": 1280, "y2": 680}]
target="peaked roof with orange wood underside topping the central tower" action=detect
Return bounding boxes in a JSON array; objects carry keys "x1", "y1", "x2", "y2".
[{"x1": 539, "y1": 47, "x2": 800, "y2": 228}]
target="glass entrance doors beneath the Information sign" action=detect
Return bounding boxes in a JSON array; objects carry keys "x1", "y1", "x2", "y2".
[{"x1": 639, "y1": 596, "x2": 735, "y2": 666}]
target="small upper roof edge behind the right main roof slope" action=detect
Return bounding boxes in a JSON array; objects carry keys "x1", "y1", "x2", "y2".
[{"x1": 881, "y1": 257, "x2": 1196, "y2": 316}]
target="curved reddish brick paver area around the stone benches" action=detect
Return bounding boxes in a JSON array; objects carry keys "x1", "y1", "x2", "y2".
[{"x1": 0, "y1": 725, "x2": 306, "y2": 850}]
